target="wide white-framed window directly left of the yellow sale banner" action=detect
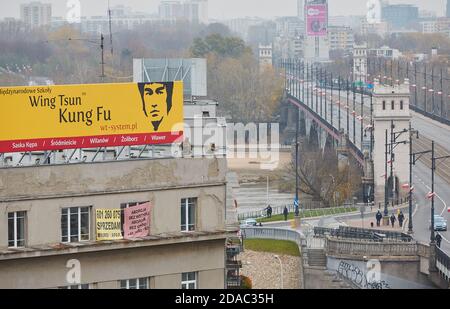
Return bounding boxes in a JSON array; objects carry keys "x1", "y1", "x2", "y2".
[{"x1": 61, "y1": 207, "x2": 90, "y2": 242}]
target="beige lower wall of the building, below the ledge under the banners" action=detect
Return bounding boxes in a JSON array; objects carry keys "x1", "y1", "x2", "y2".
[{"x1": 0, "y1": 240, "x2": 225, "y2": 289}]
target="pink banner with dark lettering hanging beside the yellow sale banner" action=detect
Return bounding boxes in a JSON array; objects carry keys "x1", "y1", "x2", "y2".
[{"x1": 123, "y1": 203, "x2": 150, "y2": 239}]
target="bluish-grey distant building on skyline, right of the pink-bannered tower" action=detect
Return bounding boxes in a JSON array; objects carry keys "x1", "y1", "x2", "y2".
[{"x1": 381, "y1": 4, "x2": 419, "y2": 30}]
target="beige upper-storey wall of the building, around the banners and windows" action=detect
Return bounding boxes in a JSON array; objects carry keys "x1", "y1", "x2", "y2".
[{"x1": 0, "y1": 159, "x2": 226, "y2": 248}]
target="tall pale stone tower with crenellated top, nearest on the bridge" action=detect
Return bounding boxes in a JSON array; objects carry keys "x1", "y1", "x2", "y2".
[{"x1": 373, "y1": 80, "x2": 411, "y2": 205}]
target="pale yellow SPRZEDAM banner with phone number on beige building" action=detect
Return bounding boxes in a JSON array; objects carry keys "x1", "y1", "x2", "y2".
[{"x1": 95, "y1": 209, "x2": 123, "y2": 240}]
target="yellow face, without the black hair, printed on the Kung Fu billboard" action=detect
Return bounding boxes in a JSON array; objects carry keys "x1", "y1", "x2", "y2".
[{"x1": 144, "y1": 83, "x2": 167, "y2": 123}]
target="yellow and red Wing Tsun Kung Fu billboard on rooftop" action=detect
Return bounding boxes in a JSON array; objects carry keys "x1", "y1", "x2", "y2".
[{"x1": 0, "y1": 81, "x2": 184, "y2": 153}]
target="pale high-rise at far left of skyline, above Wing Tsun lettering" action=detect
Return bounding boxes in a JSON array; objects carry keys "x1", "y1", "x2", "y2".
[{"x1": 20, "y1": 2, "x2": 52, "y2": 28}]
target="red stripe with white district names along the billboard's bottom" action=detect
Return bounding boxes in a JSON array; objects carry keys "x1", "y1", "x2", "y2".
[{"x1": 0, "y1": 132, "x2": 183, "y2": 153}]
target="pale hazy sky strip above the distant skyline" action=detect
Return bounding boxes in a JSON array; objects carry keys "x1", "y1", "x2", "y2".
[{"x1": 0, "y1": 0, "x2": 446, "y2": 19}]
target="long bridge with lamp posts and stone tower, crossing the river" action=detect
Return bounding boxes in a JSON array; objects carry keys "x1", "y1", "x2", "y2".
[{"x1": 280, "y1": 59, "x2": 450, "y2": 280}]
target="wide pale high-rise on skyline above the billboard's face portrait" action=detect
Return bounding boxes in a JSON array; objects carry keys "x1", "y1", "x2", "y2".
[{"x1": 159, "y1": 0, "x2": 208, "y2": 24}]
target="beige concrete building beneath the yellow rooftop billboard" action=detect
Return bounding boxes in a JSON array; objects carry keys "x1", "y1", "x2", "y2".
[{"x1": 0, "y1": 97, "x2": 237, "y2": 289}]
